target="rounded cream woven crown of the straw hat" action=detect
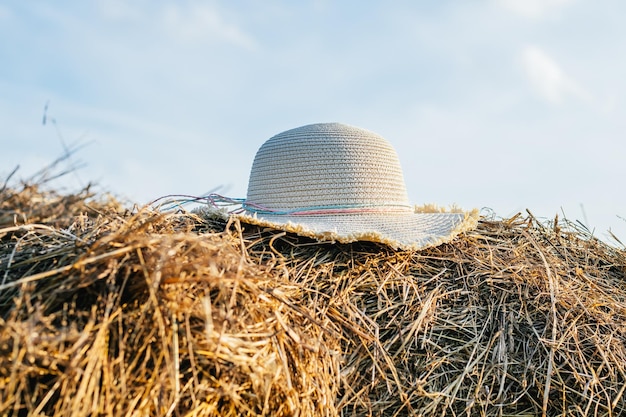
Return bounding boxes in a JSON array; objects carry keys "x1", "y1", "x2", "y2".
[{"x1": 246, "y1": 123, "x2": 411, "y2": 211}]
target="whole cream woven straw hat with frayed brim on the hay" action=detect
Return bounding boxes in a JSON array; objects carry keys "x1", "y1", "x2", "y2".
[{"x1": 224, "y1": 123, "x2": 478, "y2": 249}]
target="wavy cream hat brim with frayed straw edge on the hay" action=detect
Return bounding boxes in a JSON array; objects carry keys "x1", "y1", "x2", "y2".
[{"x1": 231, "y1": 207, "x2": 479, "y2": 250}]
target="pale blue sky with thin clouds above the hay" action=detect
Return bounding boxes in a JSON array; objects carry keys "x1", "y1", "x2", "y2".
[{"x1": 0, "y1": 0, "x2": 626, "y2": 243}]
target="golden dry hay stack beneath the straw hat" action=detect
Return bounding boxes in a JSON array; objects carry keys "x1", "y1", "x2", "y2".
[{"x1": 0, "y1": 185, "x2": 626, "y2": 416}]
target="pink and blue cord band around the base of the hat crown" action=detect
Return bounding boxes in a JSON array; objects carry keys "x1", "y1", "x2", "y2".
[{"x1": 241, "y1": 201, "x2": 412, "y2": 216}]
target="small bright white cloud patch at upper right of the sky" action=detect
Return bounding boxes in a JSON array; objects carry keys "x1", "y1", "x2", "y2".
[{"x1": 521, "y1": 46, "x2": 588, "y2": 103}]
